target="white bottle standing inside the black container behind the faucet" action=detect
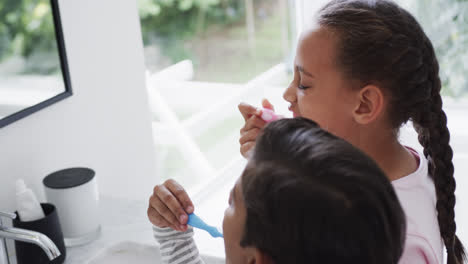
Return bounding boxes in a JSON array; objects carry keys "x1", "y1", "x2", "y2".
[{"x1": 16, "y1": 179, "x2": 45, "y2": 222}]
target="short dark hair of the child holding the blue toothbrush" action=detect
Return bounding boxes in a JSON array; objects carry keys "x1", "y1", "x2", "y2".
[{"x1": 241, "y1": 118, "x2": 406, "y2": 264}]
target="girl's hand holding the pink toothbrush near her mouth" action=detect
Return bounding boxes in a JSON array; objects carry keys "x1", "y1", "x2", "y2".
[{"x1": 238, "y1": 99, "x2": 274, "y2": 158}]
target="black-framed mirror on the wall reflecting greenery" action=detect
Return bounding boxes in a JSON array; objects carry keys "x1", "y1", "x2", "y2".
[{"x1": 0, "y1": 0, "x2": 72, "y2": 128}]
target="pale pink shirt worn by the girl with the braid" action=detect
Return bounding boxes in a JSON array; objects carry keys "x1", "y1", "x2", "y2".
[{"x1": 392, "y1": 148, "x2": 444, "y2": 264}]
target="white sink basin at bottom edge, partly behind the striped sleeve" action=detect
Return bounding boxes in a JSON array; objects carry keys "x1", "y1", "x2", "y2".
[{"x1": 87, "y1": 241, "x2": 225, "y2": 264}]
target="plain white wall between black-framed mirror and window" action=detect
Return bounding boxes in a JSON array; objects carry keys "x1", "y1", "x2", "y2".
[{"x1": 0, "y1": 0, "x2": 156, "y2": 211}]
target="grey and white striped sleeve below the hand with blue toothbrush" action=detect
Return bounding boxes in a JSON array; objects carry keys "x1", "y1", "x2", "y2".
[{"x1": 153, "y1": 226, "x2": 204, "y2": 264}]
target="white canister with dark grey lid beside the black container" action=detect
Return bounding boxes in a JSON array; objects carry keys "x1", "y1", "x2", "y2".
[{"x1": 43, "y1": 168, "x2": 101, "y2": 247}]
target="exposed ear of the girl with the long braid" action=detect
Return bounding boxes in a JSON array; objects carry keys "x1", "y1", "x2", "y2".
[{"x1": 353, "y1": 85, "x2": 384, "y2": 125}]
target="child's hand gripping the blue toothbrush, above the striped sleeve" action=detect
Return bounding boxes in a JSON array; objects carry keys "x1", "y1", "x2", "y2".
[{"x1": 147, "y1": 179, "x2": 194, "y2": 231}]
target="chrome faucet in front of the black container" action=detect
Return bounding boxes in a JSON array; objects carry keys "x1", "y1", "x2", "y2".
[{"x1": 0, "y1": 212, "x2": 60, "y2": 263}]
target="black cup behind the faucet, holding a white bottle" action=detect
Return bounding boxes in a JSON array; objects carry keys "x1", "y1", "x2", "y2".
[{"x1": 13, "y1": 203, "x2": 66, "y2": 264}]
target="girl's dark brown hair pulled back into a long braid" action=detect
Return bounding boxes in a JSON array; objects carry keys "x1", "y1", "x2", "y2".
[{"x1": 318, "y1": 0, "x2": 466, "y2": 264}]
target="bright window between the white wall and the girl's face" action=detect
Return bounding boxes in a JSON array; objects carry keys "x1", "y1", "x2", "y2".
[{"x1": 138, "y1": 0, "x2": 295, "y2": 192}]
